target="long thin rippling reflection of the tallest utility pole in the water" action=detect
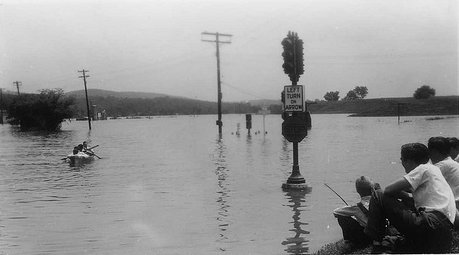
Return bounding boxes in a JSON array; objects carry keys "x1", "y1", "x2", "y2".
[{"x1": 214, "y1": 137, "x2": 231, "y2": 251}]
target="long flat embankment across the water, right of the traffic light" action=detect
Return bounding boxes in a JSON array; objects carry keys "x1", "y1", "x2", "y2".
[{"x1": 308, "y1": 96, "x2": 459, "y2": 116}]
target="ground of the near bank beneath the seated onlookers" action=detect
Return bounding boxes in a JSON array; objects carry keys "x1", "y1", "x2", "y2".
[{"x1": 313, "y1": 230, "x2": 459, "y2": 255}]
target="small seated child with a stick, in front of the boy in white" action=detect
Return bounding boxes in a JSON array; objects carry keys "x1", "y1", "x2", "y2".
[{"x1": 333, "y1": 176, "x2": 379, "y2": 246}]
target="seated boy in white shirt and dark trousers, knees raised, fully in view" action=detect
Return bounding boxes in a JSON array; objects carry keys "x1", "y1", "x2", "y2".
[{"x1": 365, "y1": 143, "x2": 456, "y2": 253}]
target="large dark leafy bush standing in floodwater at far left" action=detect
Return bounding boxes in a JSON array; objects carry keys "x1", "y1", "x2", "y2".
[{"x1": 8, "y1": 89, "x2": 74, "y2": 131}]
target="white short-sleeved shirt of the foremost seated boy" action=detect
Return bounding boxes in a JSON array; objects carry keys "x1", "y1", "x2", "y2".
[{"x1": 404, "y1": 164, "x2": 456, "y2": 223}]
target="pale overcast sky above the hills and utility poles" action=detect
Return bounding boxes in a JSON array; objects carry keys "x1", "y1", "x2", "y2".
[{"x1": 0, "y1": 0, "x2": 459, "y2": 101}]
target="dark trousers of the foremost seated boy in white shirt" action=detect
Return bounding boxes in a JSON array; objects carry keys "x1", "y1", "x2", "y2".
[{"x1": 365, "y1": 190, "x2": 452, "y2": 253}]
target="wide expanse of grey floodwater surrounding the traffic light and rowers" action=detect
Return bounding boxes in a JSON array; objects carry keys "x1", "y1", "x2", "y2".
[{"x1": 0, "y1": 115, "x2": 459, "y2": 254}]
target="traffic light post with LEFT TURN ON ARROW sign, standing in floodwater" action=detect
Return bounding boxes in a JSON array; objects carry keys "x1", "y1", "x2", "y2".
[{"x1": 282, "y1": 32, "x2": 309, "y2": 190}]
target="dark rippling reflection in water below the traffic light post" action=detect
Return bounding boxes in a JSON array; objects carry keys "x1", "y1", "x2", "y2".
[{"x1": 282, "y1": 189, "x2": 311, "y2": 255}]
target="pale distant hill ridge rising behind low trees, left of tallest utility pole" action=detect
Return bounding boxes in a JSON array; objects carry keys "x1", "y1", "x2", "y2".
[{"x1": 65, "y1": 89, "x2": 180, "y2": 99}]
